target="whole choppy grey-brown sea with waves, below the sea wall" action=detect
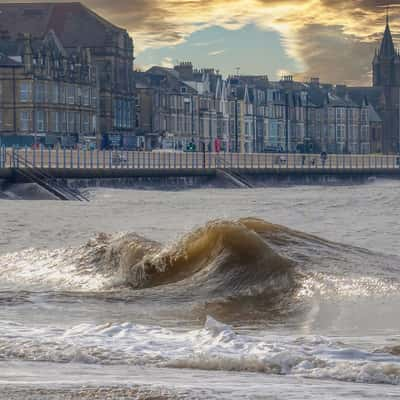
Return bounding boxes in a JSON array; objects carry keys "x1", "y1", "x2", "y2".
[{"x1": 0, "y1": 180, "x2": 400, "y2": 400}]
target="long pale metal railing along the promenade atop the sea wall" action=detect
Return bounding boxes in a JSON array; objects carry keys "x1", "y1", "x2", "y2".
[{"x1": 0, "y1": 146, "x2": 400, "y2": 170}]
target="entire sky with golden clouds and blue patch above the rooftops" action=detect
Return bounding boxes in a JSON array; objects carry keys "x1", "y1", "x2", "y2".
[{"x1": 10, "y1": 0, "x2": 400, "y2": 85}]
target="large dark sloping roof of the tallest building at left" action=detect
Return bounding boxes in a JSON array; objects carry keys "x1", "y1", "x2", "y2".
[{"x1": 0, "y1": 2, "x2": 126, "y2": 47}]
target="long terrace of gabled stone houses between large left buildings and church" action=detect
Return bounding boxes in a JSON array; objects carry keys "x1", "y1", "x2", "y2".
[{"x1": 136, "y1": 63, "x2": 381, "y2": 154}]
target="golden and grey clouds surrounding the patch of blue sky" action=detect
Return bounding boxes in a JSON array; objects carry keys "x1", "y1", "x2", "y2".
[{"x1": 7, "y1": 0, "x2": 400, "y2": 84}]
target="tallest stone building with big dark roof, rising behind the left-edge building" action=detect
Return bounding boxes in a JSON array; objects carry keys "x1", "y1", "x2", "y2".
[{"x1": 0, "y1": 3, "x2": 136, "y2": 147}]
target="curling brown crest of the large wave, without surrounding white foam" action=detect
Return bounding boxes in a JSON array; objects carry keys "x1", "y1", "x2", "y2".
[{"x1": 79, "y1": 219, "x2": 293, "y2": 291}]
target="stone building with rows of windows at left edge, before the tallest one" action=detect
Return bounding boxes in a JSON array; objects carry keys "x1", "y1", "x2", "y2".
[{"x1": 0, "y1": 31, "x2": 99, "y2": 146}]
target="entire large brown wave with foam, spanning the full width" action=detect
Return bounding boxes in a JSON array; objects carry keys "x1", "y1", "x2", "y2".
[{"x1": 0, "y1": 218, "x2": 400, "y2": 314}]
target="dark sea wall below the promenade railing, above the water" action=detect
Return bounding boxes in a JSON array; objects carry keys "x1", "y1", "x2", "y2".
[{"x1": 0, "y1": 168, "x2": 400, "y2": 197}]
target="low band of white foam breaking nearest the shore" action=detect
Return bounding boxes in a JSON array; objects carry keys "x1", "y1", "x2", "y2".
[{"x1": 0, "y1": 317, "x2": 400, "y2": 385}]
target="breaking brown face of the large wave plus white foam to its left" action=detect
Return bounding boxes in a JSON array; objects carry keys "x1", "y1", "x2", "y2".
[{"x1": 0, "y1": 219, "x2": 294, "y2": 291}]
